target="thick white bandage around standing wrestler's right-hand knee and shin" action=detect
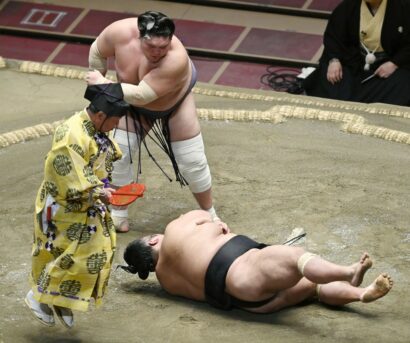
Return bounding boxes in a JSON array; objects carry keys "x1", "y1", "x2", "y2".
[{"x1": 171, "y1": 133, "x2": 211, "y2": 193}]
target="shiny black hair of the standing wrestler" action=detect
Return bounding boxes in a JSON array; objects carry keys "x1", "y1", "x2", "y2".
[{"x1": 138, "y1": 11, "x2": 175, "y2": 38}]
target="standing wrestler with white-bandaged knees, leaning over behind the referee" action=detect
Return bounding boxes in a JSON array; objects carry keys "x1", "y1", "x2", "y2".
[{"x1": 86, "y1": 11, "x2": 217, "y2": 232}]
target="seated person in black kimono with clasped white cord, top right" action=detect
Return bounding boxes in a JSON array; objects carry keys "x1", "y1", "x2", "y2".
[{"x1": 304, "y1": 0, "x2": 410, "y2": 106}]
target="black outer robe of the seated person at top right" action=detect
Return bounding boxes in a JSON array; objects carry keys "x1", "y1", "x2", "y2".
[{"x1": 304, "y1": 0, "x2": 410, "y2": 106}]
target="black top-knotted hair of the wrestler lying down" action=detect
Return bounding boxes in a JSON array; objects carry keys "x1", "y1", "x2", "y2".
[{"x1": 121, "y1": 239, "x2": 155, "y2": 280}]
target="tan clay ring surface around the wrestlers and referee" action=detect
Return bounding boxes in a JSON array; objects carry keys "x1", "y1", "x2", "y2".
[{"x1": 0, "y1": 69, "x2": 410, "y2": 343}]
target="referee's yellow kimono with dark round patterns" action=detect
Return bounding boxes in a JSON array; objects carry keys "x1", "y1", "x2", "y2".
[{"x1": 30, "y1": 110, "x2": 121, "y2": 311}]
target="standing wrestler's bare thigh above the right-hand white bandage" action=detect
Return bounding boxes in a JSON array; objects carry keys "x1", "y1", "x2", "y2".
[{"x1": 169, "y1": 93, "x2": 201, "y2": 142}]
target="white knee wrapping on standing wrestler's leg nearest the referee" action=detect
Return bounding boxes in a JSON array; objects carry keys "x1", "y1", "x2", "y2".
[{"x1": 112, "y1": 129, "x2": 138, "y2": 186}]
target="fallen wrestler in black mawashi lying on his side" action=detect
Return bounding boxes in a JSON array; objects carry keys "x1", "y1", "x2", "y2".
[{"x1": 121, "y1": 210, "x2": 393, "y2": 313}]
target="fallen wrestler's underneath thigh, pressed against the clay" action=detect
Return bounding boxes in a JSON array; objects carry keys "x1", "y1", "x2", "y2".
[{"x1": 243, "y1": 278, "x2": 316, "y2": 313}]
